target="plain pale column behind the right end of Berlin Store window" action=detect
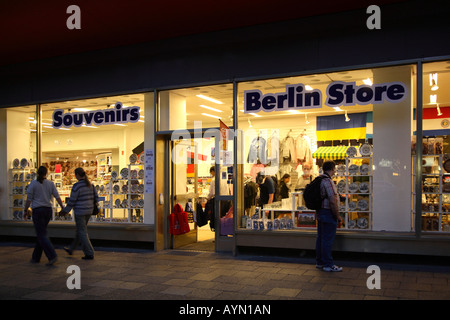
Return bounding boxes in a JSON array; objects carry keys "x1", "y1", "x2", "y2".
[{"x1": 373, "y1": 66, "x2": 412, "y2": 231}]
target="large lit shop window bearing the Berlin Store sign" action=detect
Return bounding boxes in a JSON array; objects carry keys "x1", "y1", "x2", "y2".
[{"x1": 237, "y1": 66, "x2": 415, "y2": 231}]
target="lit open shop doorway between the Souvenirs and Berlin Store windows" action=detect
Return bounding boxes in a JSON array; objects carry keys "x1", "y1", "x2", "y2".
[{"x1": 155, "y1": 134, "x2": 233, "y2": 251}]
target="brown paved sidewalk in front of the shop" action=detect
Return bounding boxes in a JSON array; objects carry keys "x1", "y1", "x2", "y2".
[{"x1": 0, "y1": 244, "x2": 450, "y2": 301}]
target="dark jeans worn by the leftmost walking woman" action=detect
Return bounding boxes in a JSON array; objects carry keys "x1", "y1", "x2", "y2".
[{"x1": 31, "y1": 207, "x2": 56, "y2": 262}]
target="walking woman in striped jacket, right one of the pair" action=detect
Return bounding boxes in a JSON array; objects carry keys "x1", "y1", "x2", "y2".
[{"x1": 61, "y1": 168, "x2": 98, "y2": 260}]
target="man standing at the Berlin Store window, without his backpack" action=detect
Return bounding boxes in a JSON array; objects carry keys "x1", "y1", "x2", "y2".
[{"x1": 316, "y1": 161, "x2": 342, "y2": 272}]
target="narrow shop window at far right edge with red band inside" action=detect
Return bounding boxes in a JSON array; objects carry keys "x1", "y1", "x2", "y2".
[{"x1": 420, "y1": 61, "x2": 450, "y2": 232}]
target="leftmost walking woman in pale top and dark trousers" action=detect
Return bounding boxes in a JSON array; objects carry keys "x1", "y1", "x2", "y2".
[{"x1": 25, "y1": 166, "x2": 63, "y2": 266}]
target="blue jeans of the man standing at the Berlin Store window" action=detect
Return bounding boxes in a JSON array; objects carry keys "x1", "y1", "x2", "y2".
[{"x1": 316, "y1": 209, "x2": 337, "y2": 267}]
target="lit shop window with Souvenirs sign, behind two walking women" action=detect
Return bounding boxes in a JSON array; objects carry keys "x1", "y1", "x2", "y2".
[{"x1": 3, "y1": 94, "x2": 149, "y2": 223}]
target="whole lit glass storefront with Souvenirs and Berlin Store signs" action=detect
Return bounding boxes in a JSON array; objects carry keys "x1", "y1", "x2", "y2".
[{"x1": 0, "y1": 0, "x2": 450, "y2": 256}]
